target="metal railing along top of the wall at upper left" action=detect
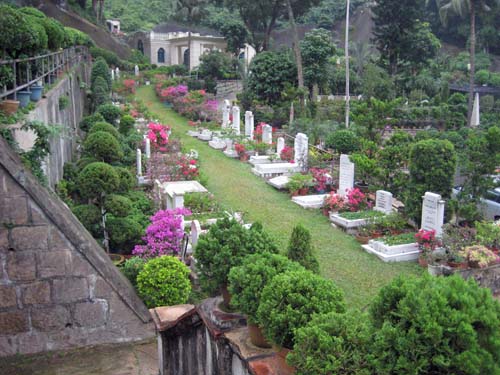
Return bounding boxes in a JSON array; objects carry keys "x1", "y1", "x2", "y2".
[{"x1": 0, "y1": 46, "x2": 90, "y2": 100}]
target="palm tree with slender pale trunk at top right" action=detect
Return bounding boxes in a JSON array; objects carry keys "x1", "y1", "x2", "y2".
[{"x1": 432, "y1": 0, "x2": 500, "y2": 126}]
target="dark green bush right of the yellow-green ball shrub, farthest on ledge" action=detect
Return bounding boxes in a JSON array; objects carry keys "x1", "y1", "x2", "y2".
[{"x1": 195, "y1": 218, "x2": 277, "y2": 293}]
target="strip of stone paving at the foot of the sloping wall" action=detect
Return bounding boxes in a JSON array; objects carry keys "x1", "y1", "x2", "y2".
[{"x1": 0, "y1": 339, "x2": 159, "y2": 375}]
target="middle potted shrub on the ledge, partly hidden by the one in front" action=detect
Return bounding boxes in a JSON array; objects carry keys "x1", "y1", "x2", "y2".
[{"x1": 228, "y1": 253, "x2": 303, "y2": 324}]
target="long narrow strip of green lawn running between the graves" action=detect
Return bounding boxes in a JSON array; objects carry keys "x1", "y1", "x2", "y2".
[{"x1": 137, "y1": 86, "x2": 422, "y2": 308}]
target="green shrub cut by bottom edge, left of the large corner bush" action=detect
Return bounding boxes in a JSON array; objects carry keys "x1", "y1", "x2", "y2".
[{"x1": 287, "y1": 310, "x2": 374, "y2": 375}]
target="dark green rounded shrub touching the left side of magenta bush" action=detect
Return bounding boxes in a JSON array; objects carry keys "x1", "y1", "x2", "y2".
[{"x1": 106, "y1": 215, "x2": 144, "y2": 255}]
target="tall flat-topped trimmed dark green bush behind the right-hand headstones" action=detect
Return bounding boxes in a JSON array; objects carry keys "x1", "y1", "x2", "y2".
[{"x1": 405, "y1": 139, "x2": 457, "y2": 222}]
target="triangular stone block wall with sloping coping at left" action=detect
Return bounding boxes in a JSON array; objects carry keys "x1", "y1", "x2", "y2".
[{"x1": 0, "y1": 138, "x2": 154, "y2": 357}]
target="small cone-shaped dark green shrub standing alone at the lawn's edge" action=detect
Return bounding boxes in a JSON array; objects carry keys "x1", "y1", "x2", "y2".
[{"x1": 287, "y1": 224, "x2": 319, "y2": 273}]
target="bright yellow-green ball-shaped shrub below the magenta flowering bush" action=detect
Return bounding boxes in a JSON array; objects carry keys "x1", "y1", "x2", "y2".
[{"x1": 137, "y1": 255, "x2": 191, "y2": 308}]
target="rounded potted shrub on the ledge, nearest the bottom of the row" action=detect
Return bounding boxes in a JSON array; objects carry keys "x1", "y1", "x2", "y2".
[{"x1": 257, "y1": 271, "x2": 345, "y2": 349}]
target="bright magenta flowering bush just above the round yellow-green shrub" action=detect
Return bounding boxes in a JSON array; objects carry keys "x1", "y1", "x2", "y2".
[{"x1": 132, "y1": 208, "x2": 191, "y2": 258}]
